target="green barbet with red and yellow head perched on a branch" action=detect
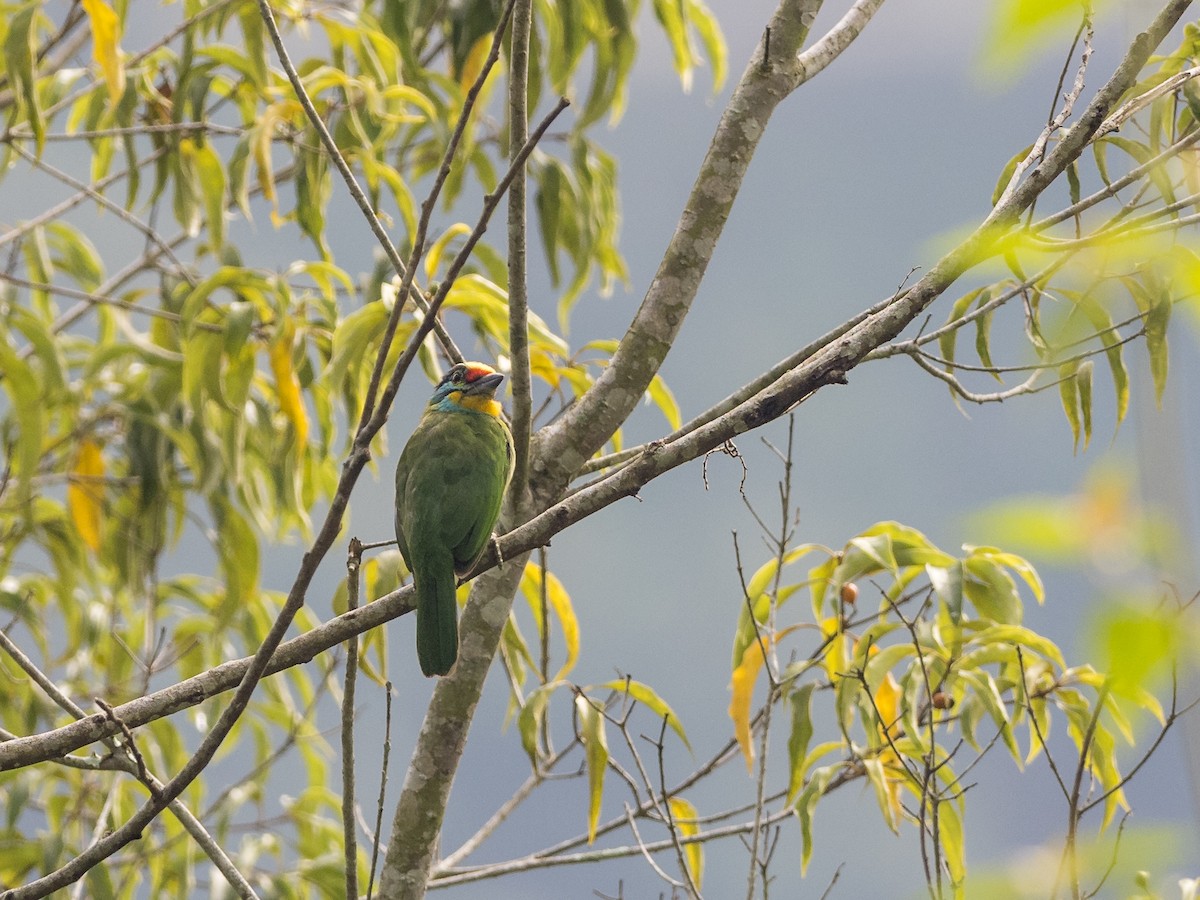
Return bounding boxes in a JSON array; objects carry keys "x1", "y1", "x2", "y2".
[{"x1": 396, "y1": 362, "x2": 514, "y2": 677}]
